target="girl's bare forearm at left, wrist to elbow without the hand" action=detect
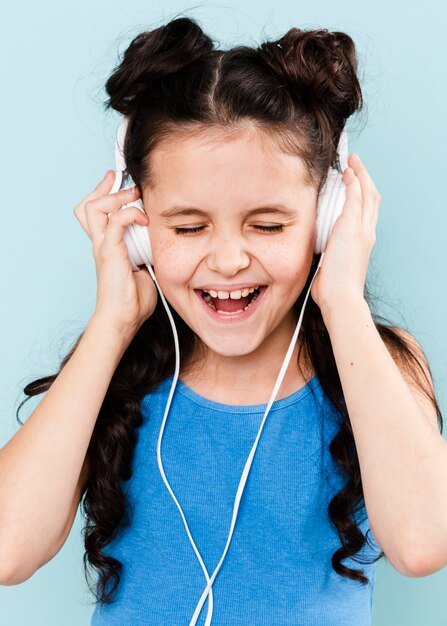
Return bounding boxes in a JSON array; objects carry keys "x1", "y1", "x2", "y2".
[{"x1": 0, "y1": 315, "x2": 131, "y2": 584}]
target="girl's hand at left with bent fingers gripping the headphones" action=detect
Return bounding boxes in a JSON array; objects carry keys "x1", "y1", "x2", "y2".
[{"x1": 73, "y1": 170, "x2": 157, "y2": 336}]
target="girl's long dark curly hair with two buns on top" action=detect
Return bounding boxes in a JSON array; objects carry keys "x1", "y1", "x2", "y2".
[{"x1": 17, "y1": 17, "x2": 443, "y2": 603}]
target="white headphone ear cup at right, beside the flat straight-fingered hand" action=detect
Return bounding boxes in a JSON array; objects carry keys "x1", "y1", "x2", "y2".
[{"x1": 314, "y1": 168, "x2": 346, "y2": 254}]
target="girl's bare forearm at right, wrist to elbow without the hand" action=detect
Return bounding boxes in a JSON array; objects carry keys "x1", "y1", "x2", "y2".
[{"x1": 322, "y1": 297, "x2": 447, "y2": 576}]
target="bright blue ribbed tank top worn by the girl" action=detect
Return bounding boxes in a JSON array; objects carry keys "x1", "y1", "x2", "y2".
[{"x1": 91, "y1": 376, "x2": 380, "y2": 626}]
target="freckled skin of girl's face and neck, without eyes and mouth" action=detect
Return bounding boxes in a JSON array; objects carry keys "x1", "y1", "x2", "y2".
[{"x1": 143, "y1": 127, "x2": 317, "y2": 404}]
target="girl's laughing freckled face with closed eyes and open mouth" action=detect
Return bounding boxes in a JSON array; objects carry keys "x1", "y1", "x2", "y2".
[{"x1": 142, "y1": 128, "x2": 317, "y2": 356}]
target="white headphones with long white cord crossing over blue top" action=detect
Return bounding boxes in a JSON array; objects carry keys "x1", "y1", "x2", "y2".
[{"x1": 109, "y1": 117, "x2": 348, "y2": 626}]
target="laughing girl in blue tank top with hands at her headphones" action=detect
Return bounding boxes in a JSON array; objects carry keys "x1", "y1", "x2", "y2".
[{"x1": 0, "y1": 13, "x2": 447, "y2": 626}]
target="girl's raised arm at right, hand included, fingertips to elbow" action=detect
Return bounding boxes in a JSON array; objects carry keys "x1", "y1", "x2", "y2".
[{"x1": 311, "y1": 154, "x2": 447, "y2": 576}]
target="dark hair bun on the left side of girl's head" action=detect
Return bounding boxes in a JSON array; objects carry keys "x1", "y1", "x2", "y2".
[{"x1": 106, "y1": 17, "x2": 213, "y2": 115}]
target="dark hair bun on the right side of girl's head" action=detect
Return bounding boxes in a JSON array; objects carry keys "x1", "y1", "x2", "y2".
[{"x1": 258, "y1": 28, "x2": 362, "y2": 122}]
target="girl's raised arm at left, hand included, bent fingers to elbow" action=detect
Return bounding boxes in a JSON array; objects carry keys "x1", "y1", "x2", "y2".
[{"x1": 0, "y1": 170, "x2": 157, "y2": 584}]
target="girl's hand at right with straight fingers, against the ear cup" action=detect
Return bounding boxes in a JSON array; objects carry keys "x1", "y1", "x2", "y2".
[{"x1": 311, "y1": 154, "x2": 381, "y2": 312}]
